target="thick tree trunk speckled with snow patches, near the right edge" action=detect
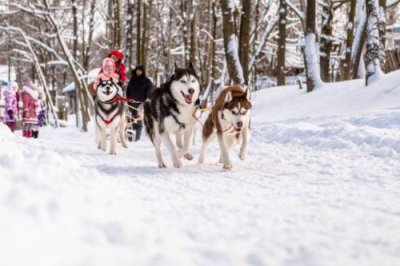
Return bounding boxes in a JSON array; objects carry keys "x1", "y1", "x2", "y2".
[{"x1": 365, "y1": 0, "x2": 381, "y2": 86}]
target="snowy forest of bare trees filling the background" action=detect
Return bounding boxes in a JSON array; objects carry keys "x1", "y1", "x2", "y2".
[{"x1": 0, "y1": 0, "x2": 400, "y2": 130}]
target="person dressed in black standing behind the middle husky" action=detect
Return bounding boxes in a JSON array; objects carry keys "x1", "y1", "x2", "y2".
[{"x1": 126, "y1": 65, "x2": 153, "y2": 141}]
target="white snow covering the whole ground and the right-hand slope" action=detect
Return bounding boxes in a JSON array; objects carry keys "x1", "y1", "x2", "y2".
[{"x1": 0, "y1": 72, "x2": 400, "y2": 266}]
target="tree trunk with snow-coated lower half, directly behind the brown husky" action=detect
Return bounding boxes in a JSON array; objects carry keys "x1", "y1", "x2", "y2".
[{"x1": 220, "y1": 0, "x2": 244, "y2": 84}]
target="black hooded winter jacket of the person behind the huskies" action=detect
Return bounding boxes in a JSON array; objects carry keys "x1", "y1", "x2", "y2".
[{"x1": 126, "y1": 65, "x2": 153, "y2": 102}]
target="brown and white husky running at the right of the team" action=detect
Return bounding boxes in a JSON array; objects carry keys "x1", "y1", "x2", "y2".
[{"x1": 198, "y1": 85, "x2": 252, "y2": 170}]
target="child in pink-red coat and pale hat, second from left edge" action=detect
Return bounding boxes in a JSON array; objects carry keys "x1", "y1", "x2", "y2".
[{"x1": 21, "y1": 80, "x2": 40, "y2": 138}]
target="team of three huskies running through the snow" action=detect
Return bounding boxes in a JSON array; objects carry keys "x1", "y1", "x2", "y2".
[{"x1": 95, "y1": 64, "x2": 252, "y2": 170}]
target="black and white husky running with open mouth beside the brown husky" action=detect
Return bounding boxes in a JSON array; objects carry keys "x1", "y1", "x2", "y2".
[{"x1": 144, "y1": 64, "x2": 200, "y2": 168}]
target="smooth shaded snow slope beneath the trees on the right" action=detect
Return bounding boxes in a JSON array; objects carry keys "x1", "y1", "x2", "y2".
[{"x1": 253, "y1": 71, "x2": 400, "y2": 122}]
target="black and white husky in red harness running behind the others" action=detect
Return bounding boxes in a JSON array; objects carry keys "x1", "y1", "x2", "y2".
[{"x1": 95, "y1": 79, "x2": 128, "y2": 154}]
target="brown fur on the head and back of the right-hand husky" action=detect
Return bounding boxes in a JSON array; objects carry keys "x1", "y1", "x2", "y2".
[{"x1": 203, "y1": 85, "x2": 251, "y2": 139}]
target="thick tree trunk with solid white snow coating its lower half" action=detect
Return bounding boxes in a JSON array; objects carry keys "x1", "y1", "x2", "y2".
[{"x1": 304, "y1": 0, "x2": 322, "y2": 92}]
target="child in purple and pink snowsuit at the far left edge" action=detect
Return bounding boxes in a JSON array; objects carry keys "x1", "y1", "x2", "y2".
[{"x1": 3, "y1": 82, "x2": 18, "y2": 132}]
